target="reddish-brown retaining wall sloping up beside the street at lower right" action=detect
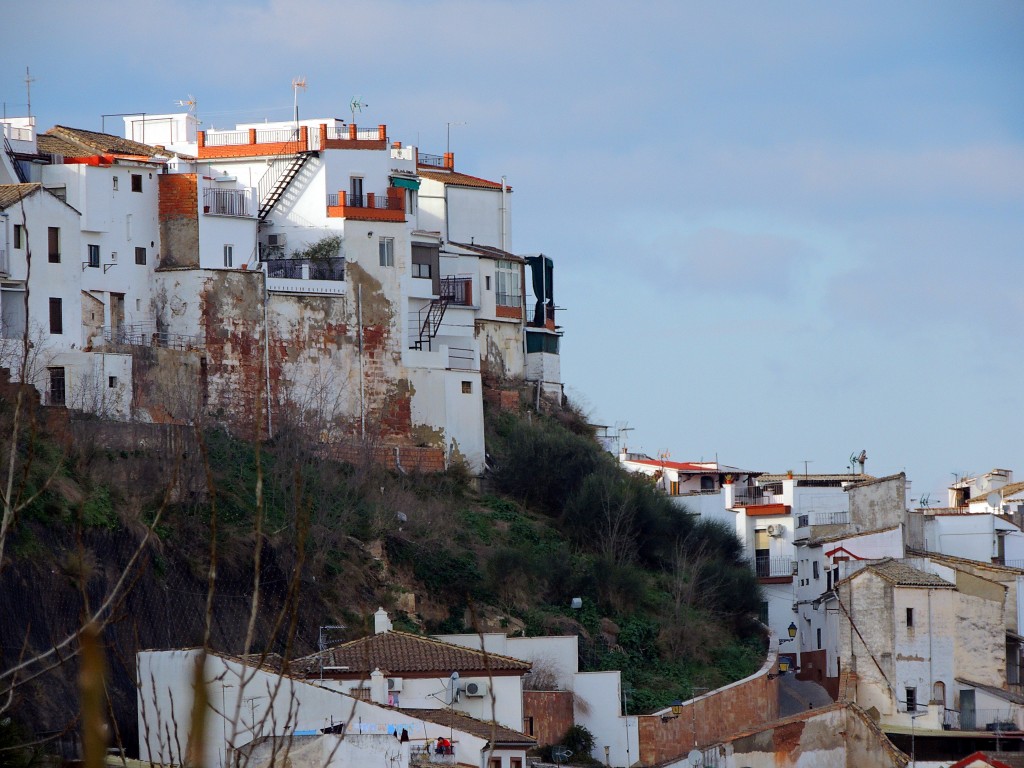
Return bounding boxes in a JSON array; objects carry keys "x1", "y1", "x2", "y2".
[{"x1": 637, "y1": 650, "x2": 778, "y2": 765}]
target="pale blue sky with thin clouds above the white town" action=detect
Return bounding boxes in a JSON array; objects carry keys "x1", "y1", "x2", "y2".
[{"x1": 0, "y1": 0, "x2": 1024, "y2": 499}]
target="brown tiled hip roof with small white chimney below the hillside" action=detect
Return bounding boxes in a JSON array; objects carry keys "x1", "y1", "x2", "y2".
[{"x1": 292, "y1": 631, "x2": 530, "y2": 677}]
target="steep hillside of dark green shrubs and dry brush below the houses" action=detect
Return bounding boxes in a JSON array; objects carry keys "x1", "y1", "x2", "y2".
[{"x1": 0, "y1": 387, "x2": 763, "y2": 753}]
